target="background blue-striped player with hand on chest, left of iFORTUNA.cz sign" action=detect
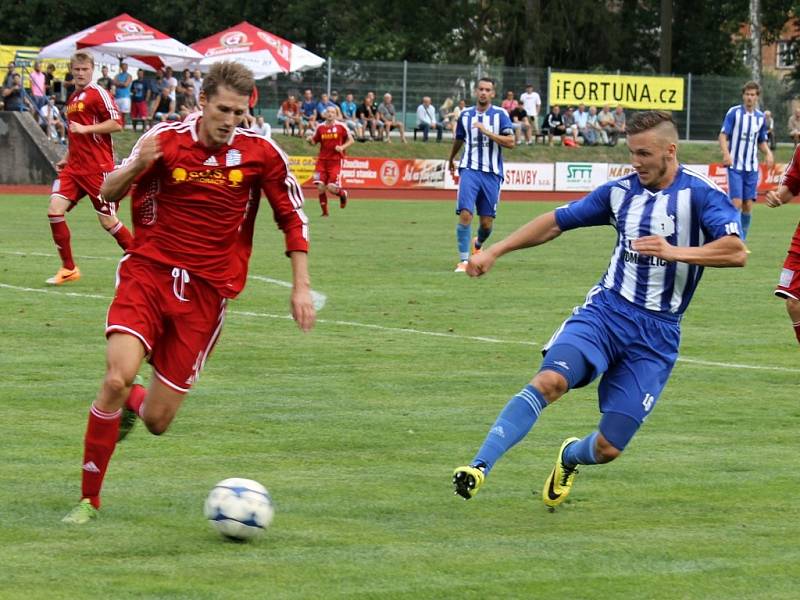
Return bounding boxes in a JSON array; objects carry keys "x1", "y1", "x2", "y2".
[{"x1": 449, "y1": 78, "x2": 514, "y2": 273}]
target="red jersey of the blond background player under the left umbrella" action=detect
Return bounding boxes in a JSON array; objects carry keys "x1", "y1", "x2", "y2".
[{"x1": 64, "y1": 83, "x2": 123, "y2": 174}]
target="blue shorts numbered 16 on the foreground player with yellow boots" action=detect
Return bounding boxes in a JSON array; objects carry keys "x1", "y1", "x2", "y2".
[{"x1": 543, "y1": 286, "x2": 680, "y2": 425}]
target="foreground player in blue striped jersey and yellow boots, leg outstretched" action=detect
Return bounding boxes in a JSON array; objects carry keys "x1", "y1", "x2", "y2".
[{"x1": 453, "y1": 111, "x2": 747, "y2": 508}]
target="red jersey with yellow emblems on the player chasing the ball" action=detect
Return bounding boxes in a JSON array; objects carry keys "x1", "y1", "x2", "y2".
[{"x1": 123, "y1": 116, "x2": 308, "y2": 298}]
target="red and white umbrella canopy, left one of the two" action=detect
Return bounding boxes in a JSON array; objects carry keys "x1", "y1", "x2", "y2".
[{"x1": 39, "y1": 13, "x2": 202, "y2": 70}]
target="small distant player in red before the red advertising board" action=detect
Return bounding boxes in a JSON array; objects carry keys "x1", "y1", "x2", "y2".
[{"x1": 308, "y1": 107, "x2": 355, "y2": 217}]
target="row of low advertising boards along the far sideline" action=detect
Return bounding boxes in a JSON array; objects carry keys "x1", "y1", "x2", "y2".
[{"x1": 289, "y1": 156, "x2": 786, "y2": 193}]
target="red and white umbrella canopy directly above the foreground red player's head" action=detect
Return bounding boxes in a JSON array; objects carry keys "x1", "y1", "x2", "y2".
[{"x1": 190, "y1": 21, "x2": 325, "y2": 79}]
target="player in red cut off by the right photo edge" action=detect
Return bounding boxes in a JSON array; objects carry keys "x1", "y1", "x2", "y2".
[{"x1": 766, "y1": 146, "x2": 800, "y2": 343}]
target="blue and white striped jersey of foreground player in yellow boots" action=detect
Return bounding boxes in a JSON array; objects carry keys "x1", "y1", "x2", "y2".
[{"x1": 555, "y1": 166, "x2": 739, "y2": 316}]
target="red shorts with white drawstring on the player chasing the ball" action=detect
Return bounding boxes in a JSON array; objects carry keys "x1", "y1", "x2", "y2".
[{"x1": 106, "y1": 255, "x2": 227, "y2": 393}]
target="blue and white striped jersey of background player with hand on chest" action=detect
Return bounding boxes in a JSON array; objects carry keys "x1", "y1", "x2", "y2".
[{"x1": 456, "y1": 106, "x2": 514, "y2": 179}]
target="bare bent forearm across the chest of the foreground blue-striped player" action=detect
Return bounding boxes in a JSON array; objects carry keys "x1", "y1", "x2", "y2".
[{"x1": 631, "y1": 235, "x2": 747, "y2": 267}]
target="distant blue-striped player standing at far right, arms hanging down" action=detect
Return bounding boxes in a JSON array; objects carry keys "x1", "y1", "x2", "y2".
[{"x1": 719, "y1": 81, "x2": 773, "y2": 240}]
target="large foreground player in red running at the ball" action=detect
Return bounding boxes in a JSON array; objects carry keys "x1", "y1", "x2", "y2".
[{"x1": 63, "y1": 62, "x2": 315, "y2": 524}]
